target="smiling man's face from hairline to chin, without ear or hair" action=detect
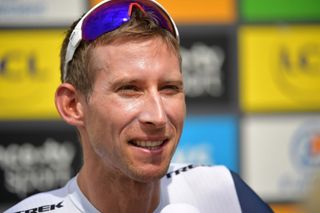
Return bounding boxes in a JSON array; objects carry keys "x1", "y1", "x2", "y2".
[{"x1": 83, "y1": 38, "x2": 186, "y2": 182}]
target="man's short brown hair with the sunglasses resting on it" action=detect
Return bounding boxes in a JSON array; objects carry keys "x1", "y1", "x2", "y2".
[{"x1": 60, "y1": 0, "x2": 181, "y2": 95}]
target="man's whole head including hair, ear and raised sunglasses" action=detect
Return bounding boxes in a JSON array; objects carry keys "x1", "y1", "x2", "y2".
[{"x1": 56, "y1": 0, "x2": 185, "y2": 182}]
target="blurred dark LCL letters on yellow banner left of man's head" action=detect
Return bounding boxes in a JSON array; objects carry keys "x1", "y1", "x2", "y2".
[{"x1": 0, "y1": 50, "x2": 45, "y2": 81}]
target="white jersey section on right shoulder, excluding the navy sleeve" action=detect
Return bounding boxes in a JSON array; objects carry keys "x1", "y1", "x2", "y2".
[{"x1": 160, "y1": 164, "x2": 241, "y2": 212}]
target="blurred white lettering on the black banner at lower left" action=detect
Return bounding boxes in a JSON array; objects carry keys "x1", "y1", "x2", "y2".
[{"x1": 0, "y1": 138, "x2": 76, "y2": 198}]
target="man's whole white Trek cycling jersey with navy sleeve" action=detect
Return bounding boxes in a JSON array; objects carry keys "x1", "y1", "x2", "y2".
[{"x1": 5, "y1": 164, "x2": 272, "y2": 213}]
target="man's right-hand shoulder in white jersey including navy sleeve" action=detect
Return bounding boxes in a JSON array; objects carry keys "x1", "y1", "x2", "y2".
[{"x1": 161, "y1": 164, "x2": 272, "y2": 212}]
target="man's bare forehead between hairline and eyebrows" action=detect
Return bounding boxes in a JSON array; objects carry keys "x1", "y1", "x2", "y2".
[{"x1": 89, "y1": 38, "x2": 181, "y2": 81}]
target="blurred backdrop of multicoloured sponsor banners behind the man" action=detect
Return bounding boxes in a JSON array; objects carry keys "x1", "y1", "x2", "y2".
[{"x1": 0, "y1": 0, "x2": 320, "y2": 213}]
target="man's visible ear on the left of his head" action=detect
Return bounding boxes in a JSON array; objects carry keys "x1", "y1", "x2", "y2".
[{"x1": 55, "y1": 83, "x2": 83, "y2": 126}]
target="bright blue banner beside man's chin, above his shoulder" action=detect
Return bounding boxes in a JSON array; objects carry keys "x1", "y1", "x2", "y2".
[{"x1": 173, "y1": 116, "x2": 239, "y2": 172}]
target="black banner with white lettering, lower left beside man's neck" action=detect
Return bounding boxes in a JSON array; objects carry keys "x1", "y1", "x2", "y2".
[{"x1": 0, "y1": 121, "x2": 81, "y2": 203}]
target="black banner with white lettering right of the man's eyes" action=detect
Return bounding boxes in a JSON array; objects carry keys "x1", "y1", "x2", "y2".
[{"x1": 180, "y1": 25, "x2": 235, "y2": 113}]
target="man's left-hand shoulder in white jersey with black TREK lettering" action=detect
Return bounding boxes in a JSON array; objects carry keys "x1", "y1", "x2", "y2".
[{"x1": 4, "y1": 181, "x2": 72, "y2": 213}]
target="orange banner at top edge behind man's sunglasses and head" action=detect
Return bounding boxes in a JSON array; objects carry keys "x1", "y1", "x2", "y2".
[{"x1": 90, "y1": 0, "x2": 236, "y2": 24}]
